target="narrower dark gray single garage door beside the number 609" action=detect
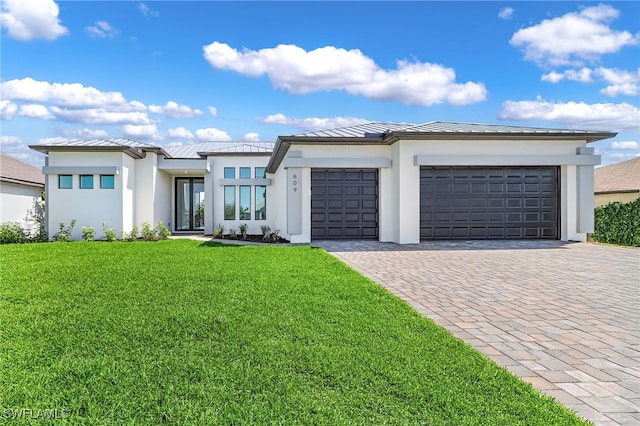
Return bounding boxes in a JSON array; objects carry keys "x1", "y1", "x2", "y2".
[{"x1": 311, "y1": 169, "x2": 378, "y2": 240}]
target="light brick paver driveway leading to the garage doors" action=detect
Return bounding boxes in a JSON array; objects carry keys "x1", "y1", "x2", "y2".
[{"x1": 314, "y1": 241, "x2": 640, "y2": 425}]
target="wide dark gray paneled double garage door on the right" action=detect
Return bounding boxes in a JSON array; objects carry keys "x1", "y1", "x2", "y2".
[{"x1": 420, "y1": 166, "x2": 559, "y2": 240}]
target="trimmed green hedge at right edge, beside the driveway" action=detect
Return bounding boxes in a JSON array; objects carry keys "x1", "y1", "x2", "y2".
[{"x1": 592, "y1": 199, "x2": 640, "y2": 247}]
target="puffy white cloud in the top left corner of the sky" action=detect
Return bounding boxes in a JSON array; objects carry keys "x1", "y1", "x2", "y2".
[{"x1": 0, "y1": 0, "x2": 69, "y2": 40}]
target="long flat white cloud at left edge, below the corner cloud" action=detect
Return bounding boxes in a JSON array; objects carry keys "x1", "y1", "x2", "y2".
[{"x1": 0, "y1": 77, "x2": 127, "y2": 108}]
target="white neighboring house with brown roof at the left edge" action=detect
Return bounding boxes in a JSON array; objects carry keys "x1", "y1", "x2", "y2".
[{"x1": 0, "y1": 153, "x2": 44, "y2": 230}]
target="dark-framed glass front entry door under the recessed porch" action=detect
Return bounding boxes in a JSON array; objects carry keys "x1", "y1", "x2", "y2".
[{"x1": 176, "y1": 178, "x2": 204, "y2": 231}]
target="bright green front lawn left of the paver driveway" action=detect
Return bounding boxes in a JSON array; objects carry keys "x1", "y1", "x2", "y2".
[{"x1": 0, "y1": 240, "x2": 586, "y2": 425}]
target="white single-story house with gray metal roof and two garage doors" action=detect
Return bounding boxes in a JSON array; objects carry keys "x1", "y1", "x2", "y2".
[{"x1": 31, "y1": 122, "x2": 615, "y2": 244}]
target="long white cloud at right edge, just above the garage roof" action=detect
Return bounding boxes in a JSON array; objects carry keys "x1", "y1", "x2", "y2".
[{"x1": 499, "y1": 99, "x2": 640, "y2": 132}]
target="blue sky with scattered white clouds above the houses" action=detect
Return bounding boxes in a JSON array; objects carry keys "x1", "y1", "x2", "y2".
[{"x1": 0, "y1": 0, "x2": 640, "y2": 165}]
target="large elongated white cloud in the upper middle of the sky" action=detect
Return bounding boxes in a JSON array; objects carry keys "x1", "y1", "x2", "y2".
[{"x1": 203, "y1": 41, "x2": 487, "y2": 106}]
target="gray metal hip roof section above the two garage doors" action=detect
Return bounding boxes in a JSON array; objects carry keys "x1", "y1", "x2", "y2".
[{"x1": 267, "y1": 121, "x2": 616, "y2": 173}]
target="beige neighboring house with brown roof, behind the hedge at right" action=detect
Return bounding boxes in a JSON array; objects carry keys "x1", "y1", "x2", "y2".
[{"x1": 594, "y1": 157, "x2": 640, "y2": 207}]
